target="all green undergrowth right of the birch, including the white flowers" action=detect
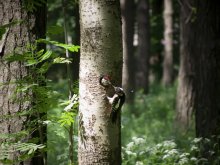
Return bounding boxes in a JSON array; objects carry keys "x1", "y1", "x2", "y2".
[{"x1": 122, "y1": 84, "x2": 220, "y2": 165}]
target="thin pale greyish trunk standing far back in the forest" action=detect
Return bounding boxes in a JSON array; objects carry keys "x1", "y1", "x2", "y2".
[{"x1": 162, "y1": 0, "x2": 173, "y2": 86}]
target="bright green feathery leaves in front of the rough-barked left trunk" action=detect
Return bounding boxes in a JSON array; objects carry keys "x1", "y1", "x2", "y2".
[{"x1": 0, "y1": 24, "x2": 79, "y2": 164}]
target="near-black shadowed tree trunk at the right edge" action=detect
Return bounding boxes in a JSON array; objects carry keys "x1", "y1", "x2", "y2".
[{"x1": 191, "y1": 0, "x2": 220, "y2": 137}]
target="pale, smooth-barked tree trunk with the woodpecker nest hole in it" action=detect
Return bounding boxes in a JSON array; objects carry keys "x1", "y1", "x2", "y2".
[{"x1": 78, "y1": 0, "x2": 122, "y2": 165}]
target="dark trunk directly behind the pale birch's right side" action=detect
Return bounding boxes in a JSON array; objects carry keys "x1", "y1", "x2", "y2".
[{"x1": 120, "y1": 0, "x2": 135, "y2": 103}]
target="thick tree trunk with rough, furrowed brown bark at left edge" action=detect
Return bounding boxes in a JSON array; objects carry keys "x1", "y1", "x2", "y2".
[{"x1": 0, "y1": 0, "x2": 46, "y2": 165}]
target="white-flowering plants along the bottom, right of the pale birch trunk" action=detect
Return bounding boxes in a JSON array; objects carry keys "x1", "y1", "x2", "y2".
[{"x1": 122, "y1": 137, "x2": 220, "y2": 165}]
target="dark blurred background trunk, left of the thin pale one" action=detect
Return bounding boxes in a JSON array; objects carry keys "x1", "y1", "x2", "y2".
[{"x1": 136, "y1": 0, "x2": 150, "y2": 93}]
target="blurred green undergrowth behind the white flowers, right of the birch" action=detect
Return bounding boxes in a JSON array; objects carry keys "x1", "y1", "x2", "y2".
[{"x1": 122, "y1": 84, "x2": 176, "y2": 145}]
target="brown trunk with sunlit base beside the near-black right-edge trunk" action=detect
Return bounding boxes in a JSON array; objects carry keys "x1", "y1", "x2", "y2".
[{"x1": 176, "y1": 0, "x2": 192, "y2": 130}]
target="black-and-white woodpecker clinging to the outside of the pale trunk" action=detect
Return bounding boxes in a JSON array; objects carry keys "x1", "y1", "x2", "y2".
[{"x1": 107, "y1": 87, "x2": 125, "y2": 123}]
